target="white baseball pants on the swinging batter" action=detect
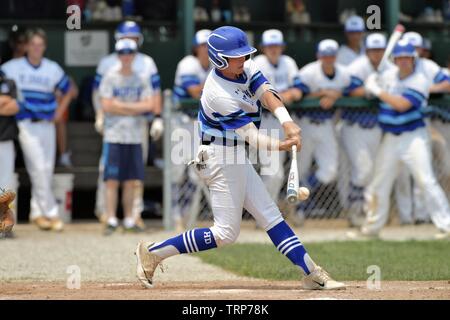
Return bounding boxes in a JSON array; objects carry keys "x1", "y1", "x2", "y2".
[{"x1": 194, "y1": 143, "x2": 283, "y2": 246}]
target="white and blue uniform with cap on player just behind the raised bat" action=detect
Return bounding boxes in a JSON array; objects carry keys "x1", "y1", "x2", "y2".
[{"x1": 339, "y1": 33, "x2": 394, "y2": 222}]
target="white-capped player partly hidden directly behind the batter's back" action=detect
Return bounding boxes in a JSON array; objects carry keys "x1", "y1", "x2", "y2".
[{"x1": 171, "y1": 29, "x2": 211, "y2": 231}]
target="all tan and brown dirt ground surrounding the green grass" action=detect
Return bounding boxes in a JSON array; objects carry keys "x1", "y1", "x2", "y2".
[{"x1": 0, "y1": 223, "x2": 450, "y2": 300}]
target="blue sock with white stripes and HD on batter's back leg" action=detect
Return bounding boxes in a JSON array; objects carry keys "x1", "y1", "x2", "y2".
[{"x1": 148, "y1": 228, "x2": 217, "y2": 259}]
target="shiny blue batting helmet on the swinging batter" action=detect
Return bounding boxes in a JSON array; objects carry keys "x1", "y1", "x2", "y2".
[{"x1": 208, "y1": 26, "x2": 256, "y2": 69}]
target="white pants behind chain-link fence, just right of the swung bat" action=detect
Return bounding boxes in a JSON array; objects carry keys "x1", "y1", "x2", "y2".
[{"x1": 294, "y1": 116, "x2": 339, "y2": 184}]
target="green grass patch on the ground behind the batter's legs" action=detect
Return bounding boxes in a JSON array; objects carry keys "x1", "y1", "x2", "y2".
[{"x1": 198, "y1": 240, "x2": 450, "y2": 280}]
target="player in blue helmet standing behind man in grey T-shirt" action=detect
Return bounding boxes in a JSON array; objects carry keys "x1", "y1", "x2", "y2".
[{"x1": 92, "y1": 21, "x2": 162, "y2": 228}]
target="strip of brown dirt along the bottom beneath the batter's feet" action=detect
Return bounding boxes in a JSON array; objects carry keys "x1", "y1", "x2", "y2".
[{"x1": 0, "y1": 280, "x2": 450, "y2": 300}]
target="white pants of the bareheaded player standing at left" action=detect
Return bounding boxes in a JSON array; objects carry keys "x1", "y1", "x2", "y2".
[{"x1": 17, "y1": 119, "x2": 59, "y2": 219}]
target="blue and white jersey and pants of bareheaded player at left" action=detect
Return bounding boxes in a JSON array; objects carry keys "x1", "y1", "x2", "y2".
[{"x1": 1, "y1": 57, "x2": 70, "y2": 219}]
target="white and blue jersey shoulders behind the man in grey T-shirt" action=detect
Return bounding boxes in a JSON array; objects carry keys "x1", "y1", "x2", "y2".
[{"x1": 95, "y1": 52, "x2": 161, "y2": 95}]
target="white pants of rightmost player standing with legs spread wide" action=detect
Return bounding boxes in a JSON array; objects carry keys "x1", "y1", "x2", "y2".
[{"x1": 362, "y1": 128, "x2": 450, "y2": 233}]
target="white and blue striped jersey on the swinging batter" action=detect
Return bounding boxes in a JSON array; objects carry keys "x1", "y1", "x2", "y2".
[{"x1": 198, "y1": 60, "x2": 268, "y2": 141}]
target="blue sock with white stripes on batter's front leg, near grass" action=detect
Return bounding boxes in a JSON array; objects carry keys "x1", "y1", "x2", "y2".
[{"x1": 267, "y1": 220, "x2": 316, "y2": 275}]
